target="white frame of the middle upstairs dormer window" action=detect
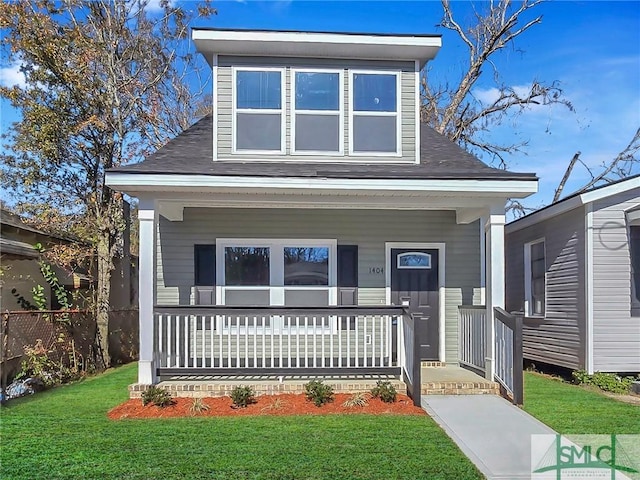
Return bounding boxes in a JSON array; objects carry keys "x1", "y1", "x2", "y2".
[{"x1": 289, "y1": 68, "x2": 344, "y2": 157}]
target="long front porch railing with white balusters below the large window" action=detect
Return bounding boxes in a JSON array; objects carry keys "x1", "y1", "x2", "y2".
[{"x1": 155, "y1": 306, "x2": 403, "y2": 375}]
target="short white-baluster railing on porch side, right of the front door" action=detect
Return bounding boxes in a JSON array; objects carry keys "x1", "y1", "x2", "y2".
[{"x1": 458, "y1": 305, "x2": 487, "y2": 372}]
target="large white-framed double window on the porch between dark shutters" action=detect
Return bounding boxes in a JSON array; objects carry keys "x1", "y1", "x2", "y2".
[{"x1": 216, "y1": 239, "x2": 337, "y2": 306}]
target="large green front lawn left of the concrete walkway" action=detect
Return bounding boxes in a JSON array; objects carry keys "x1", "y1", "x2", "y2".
[{"x1": 0, "y1": 365, "x2": 482, "y2": 480}]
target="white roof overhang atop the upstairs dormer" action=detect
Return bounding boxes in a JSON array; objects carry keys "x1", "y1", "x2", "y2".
[{"x1": 191, "y1": 28, "x2": 442, "y2": 65}]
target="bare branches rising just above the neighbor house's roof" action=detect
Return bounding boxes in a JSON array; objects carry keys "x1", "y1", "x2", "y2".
[{"x1": 553, "y1": 128, "x2": 640, "y2": 202}]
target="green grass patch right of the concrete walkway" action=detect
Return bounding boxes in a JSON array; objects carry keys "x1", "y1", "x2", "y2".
[{"x1": 524, "y1": 372, "x2": 640, "y2": 434}]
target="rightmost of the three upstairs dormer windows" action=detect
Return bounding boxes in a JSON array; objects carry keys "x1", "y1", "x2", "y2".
[{"x1": 350, "y1": 71, "x2": 400, "y2": 155}]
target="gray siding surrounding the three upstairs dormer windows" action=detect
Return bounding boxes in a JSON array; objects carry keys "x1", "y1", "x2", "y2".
[{"x1": 214, "y1": 57, "x2": 416, "y2": 162}]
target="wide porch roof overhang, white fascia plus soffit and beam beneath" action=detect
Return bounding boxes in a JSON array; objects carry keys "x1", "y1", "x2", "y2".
[{"x1": 106, "y1": 172, "x2": 538, "y2": 223}]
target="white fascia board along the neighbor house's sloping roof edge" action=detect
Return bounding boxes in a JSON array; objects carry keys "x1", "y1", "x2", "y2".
[{"x1": 505, "y1": 177, "x2": 640, "y2": 233}]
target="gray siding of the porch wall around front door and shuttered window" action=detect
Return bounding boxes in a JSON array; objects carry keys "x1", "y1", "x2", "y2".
[{"x1": 157, "y1": 208, "x2": 480, "y2": 362}]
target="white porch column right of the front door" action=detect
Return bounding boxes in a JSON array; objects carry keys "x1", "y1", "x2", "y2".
[{"x1": 484, "y1": 205, "x2": 505, "y2": 380}]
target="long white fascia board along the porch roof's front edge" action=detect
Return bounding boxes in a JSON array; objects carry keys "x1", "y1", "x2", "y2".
[{"x1": 106, "y1": 172, "x2": 538, "y2": 198}]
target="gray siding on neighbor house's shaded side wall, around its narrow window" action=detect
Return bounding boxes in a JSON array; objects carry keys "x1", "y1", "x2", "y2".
[{"x1": 505, "y1": 208, "x2": 586, "y2": 368}]
